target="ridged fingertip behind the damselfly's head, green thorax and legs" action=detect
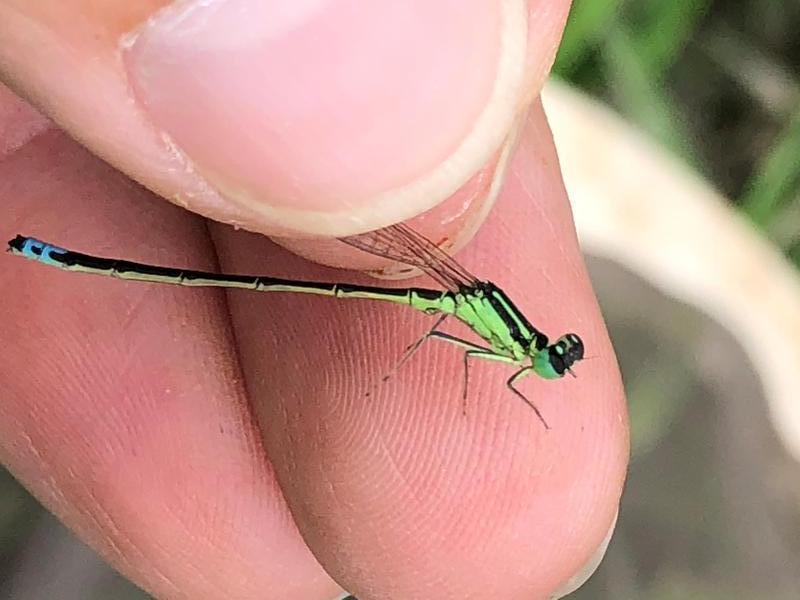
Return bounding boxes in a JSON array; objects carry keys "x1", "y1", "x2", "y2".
[{"x1": 216, "y1": 105, "x2": 628, "y2": 599}]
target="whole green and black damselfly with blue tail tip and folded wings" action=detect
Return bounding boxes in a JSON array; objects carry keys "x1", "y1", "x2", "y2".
[{"x1": 8, "y1": 225, "x2": 583, "y2": 428}]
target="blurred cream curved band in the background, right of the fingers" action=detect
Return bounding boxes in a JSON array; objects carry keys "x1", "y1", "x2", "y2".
[{"x1": 543, "y1": 83, "x2": 800, "y2": 460}]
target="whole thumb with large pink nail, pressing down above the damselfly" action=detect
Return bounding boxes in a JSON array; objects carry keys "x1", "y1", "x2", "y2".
[{"x1": 0, "y1": 0, "x2": 569, "y2": 236}]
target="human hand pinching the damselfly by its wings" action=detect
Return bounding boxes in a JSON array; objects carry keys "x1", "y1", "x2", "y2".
[{"x1": 0, "y1": 0, "x2": 627, "y2": 600}]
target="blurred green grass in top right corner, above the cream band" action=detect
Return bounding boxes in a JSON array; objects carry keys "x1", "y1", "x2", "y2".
[{"x1": 554, "y1": 0, "x2": 800, "y2": 266}]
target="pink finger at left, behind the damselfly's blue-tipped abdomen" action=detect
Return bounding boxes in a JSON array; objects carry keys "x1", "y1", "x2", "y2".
[{"x1": 0, "y1": 132, "x2": 339, "y2": 600}]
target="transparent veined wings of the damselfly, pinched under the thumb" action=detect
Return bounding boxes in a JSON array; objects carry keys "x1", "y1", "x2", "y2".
[{"x1": 339, "y1": 223, "x2": 479, "y2": 292}]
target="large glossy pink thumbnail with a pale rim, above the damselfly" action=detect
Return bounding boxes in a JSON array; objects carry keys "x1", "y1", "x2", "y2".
[{"x1": 124, "y1": 0, "x2": 525, "y2": 233}]
